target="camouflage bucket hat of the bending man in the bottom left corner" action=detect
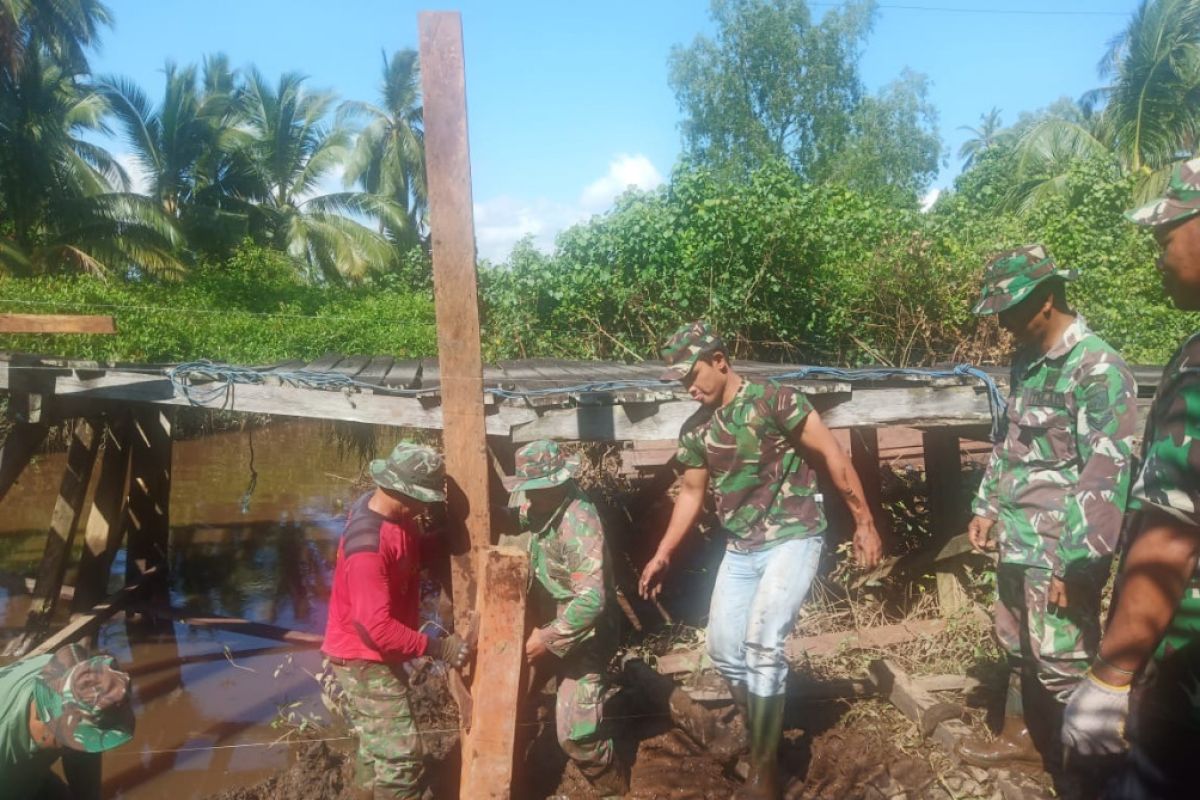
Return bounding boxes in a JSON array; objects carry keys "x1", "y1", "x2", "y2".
[{"x1": 34, "y1": 644, "x2": 133, "y2": 753}]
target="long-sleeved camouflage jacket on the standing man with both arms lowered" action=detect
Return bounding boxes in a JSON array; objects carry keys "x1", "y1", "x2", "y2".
[{"x1": 972, "y1": 317, "x2": 1138, "y2": 578}]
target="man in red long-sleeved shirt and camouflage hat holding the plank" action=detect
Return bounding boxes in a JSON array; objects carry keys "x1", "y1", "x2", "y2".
[{"x1": 320, "y1": 441, "x2": 469, "y2": 800}]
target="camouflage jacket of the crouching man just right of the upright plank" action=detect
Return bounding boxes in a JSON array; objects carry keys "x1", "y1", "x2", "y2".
[{"x1": 520, "y1": 481, "x2": 613, "y2": 658}]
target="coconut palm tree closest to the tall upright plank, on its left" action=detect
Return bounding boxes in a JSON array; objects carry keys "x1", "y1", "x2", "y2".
[{"x1": 338, "y1": 49, "x2": 427, "y2": 249}]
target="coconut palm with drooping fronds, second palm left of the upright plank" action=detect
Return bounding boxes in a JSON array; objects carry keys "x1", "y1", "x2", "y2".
[{"x1": 242, "y1": 68, "x2": 391, "y2": 281}]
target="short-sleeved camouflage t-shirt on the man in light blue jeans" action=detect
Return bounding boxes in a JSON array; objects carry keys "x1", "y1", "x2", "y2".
[{"x1": 676, "y1": 380, "x2": 826, "y2": 552}]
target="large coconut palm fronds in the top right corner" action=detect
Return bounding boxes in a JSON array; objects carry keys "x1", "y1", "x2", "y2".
[{"x1": 1015, "y1": 0, "x2": 1200, "y2": 204}]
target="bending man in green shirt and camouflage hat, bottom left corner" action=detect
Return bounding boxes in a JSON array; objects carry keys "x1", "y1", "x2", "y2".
[{"x1": 0, "y1": 644, "x2": 133, "y2": 800}]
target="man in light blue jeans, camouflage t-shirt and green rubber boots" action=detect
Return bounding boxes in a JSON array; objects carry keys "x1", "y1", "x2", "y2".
[{"x1": 640, "y1": 321, "x2": 883, "y2": 799}]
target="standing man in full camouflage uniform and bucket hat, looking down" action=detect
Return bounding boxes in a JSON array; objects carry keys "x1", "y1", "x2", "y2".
[{"x1": 959, "y1": 245, "x2": 1138, "y2": 771}]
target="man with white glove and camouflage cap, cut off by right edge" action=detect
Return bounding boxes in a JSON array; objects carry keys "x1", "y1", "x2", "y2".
[{"x1": 1063, "y1": 158, "x2": 1200, "y2": 798}]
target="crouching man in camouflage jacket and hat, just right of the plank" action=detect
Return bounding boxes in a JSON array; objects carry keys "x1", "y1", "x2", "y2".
[{"x1": 512, "y1": 439, "x2": 629, "y2": 796}]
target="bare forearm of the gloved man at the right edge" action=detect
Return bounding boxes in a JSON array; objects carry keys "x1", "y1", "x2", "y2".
[{"x1": 1092, "y1": 509, "x2": 1200, "y2": 686}]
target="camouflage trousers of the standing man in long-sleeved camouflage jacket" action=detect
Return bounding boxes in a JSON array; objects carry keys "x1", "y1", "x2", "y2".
[{"x1": 995, "y1": 564, "x2": 1103, "y2": 703}]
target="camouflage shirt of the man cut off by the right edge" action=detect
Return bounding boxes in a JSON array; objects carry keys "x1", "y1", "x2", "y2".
[{"x1": 1130, "y1": 333, "x2": 1200, "y2": 658}]
